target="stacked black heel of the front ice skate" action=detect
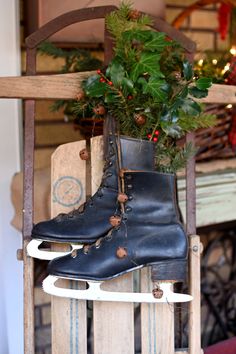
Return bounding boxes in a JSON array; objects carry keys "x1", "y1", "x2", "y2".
[{"x1": 151, "y1": 260, "x2": 187, "y2": 283}]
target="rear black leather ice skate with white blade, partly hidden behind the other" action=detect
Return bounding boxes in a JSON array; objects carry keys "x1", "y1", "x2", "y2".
[{"x1": 27, "y1": 133, "x2": 154, "y2": 260}]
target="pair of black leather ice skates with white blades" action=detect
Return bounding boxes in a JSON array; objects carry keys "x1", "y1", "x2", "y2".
[{"x1": 27, "y1": 132, "x2": 192, "y2": 302}]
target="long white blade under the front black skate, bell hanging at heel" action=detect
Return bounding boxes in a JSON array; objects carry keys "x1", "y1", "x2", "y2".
[{"x1": 43, "y1": 275, "x2": 193, "y2": 303}]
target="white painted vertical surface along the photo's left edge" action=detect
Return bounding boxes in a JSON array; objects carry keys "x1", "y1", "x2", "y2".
[{"x1": 0, "y1": 0, "x2": 24, "y2": 354}]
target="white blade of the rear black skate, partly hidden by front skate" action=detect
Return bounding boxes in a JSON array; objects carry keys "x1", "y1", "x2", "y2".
[{"x1": 27, "y1": 240, "x2": 83, "y2": 261}]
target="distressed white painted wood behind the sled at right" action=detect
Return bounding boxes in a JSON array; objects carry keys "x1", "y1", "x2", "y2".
[{"x1": 178, "y1": 171, "x2": 236, "y2": 226}]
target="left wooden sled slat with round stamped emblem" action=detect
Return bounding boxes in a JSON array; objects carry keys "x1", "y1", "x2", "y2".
[{"x1": 51, "y1": 140, "x2": 87, "y2": 354}]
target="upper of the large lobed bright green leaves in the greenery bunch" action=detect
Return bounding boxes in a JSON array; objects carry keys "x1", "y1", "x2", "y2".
[{"x1": 130, "y1": 52, "x2": 161, "y2": 82}]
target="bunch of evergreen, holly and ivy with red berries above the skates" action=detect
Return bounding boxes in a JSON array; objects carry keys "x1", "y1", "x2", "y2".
[{"x1": 40, "y1": 2, "x2": 216, "y2": 172}]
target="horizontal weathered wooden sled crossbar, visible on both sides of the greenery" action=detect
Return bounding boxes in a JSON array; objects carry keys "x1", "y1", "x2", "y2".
[{"x1": 0, "y1": 71, "x2": 236, "y2": 104}]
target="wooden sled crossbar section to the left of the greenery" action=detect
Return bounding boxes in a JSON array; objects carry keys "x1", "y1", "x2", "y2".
[{"x1": 0, "y1": 71, "x2": 95, "y2": 99}]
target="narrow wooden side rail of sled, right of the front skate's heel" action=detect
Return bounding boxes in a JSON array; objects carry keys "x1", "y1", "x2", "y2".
[{"x1": 189, "y1": 235, "x2": 202, "y2": 354}]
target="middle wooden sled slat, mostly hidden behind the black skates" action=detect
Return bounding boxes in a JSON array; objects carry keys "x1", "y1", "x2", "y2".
[{"x1": 91, "y1": 137, "x2": 134, "y2": 354}]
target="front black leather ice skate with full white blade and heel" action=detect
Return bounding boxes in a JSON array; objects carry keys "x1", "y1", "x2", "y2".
[{"x1": 43, "y1": 171, "x2": 192, "y2": 302}]
